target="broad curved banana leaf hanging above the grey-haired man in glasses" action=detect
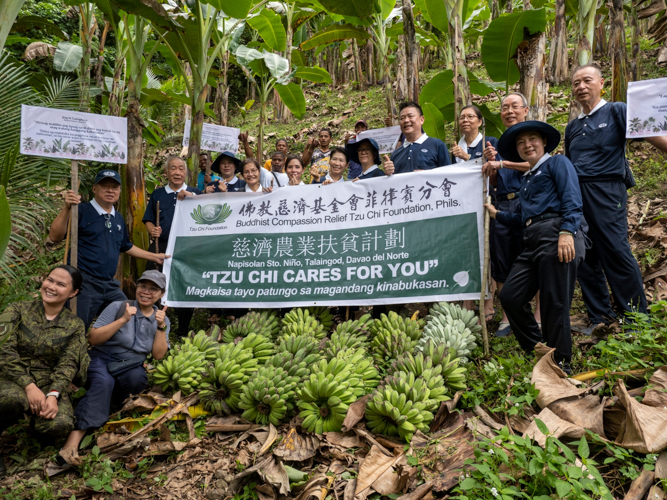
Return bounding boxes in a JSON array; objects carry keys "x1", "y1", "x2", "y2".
[{"x1": 482, "y1": 9, "x2": 547, "y2": 88}]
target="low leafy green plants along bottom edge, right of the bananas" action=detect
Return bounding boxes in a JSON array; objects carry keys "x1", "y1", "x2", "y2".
[{"x1": 452, "y1": 428, "x2": 613, "y2": 500}]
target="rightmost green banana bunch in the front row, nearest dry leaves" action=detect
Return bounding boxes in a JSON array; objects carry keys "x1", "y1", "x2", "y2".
[{"x1": 366, "y1": 386, "x2": 433, "y2": 443}]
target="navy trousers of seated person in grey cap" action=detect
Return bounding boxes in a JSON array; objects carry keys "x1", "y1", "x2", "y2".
[{"x1": 74, "y1": 349, "x2": 148, "y2": 431}]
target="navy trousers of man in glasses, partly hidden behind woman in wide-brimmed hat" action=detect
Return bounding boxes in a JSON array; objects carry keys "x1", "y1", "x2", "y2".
[{"x1": 489, "y1": 198, "x2": 523, "y2": 283}]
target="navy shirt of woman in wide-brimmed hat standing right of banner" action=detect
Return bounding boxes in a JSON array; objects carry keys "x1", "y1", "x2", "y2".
[{"x1": 496, "y1": 154, "x2": 583, "y2": 234}]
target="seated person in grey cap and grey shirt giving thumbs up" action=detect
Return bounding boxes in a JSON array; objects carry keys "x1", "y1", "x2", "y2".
[{"x1": 59, "y1": 270, "x2": 169, "y2": 465}]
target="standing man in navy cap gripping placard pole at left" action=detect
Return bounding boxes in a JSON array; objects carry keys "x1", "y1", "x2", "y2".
[{"x1": 49, "y1": 168, "x2": 169, "y2": 330}]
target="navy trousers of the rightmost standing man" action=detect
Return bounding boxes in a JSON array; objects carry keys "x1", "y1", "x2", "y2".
[{"x1": 578, "y1": 180, "x2": 646, "y2": 324}]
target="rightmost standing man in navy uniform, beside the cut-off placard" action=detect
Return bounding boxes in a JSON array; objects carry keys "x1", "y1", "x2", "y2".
[{"x1": 565, "y1": 65, "x2": 667, "y2": 333}]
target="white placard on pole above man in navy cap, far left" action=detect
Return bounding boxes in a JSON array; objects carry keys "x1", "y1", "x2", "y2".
[{"x1": 20, "y1": 104, "x2": 127, "y2": 163}]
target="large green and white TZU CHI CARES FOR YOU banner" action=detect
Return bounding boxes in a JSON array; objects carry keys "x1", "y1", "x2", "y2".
[{"x1": 164, "y1": 162, "x2": 484, "y2": 308}]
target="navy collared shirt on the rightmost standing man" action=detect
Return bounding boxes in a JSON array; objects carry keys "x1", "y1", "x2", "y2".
[{"x1": 565, "y1": 99, "x2": 627, "y2": 180}]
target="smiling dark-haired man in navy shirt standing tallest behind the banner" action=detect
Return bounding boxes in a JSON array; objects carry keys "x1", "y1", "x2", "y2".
[{"x1": 384, "y1": 101, "x2": 452, "y2": 174}]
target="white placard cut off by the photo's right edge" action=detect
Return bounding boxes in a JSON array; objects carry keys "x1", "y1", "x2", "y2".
[{"x1": 626, "y1": 78, "x2": 667, "y2": 138}]
